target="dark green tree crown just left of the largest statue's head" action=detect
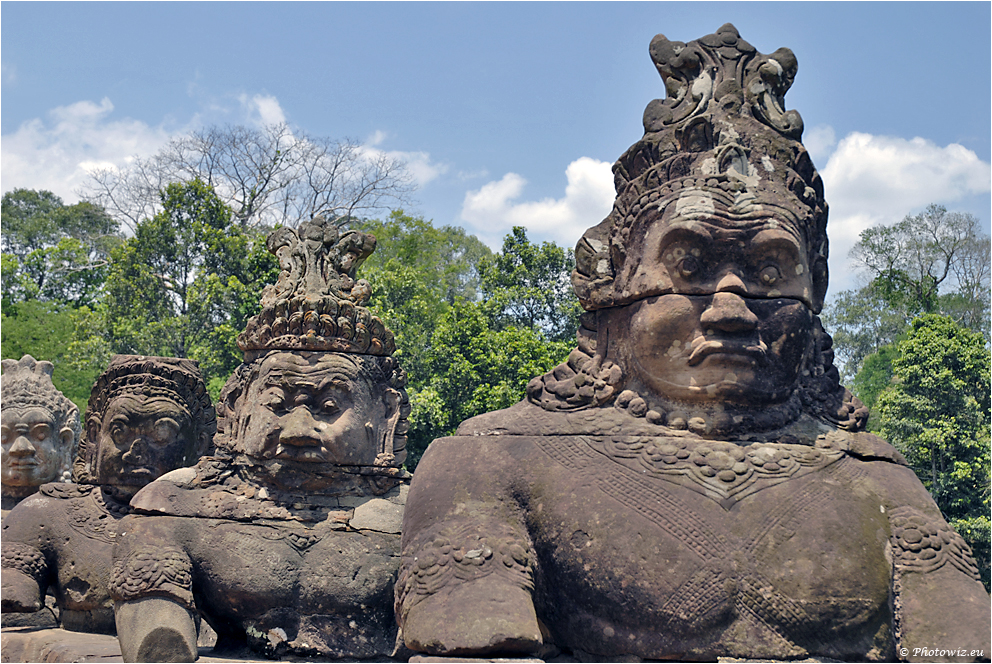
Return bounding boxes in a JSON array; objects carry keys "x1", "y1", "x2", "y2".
[{"x1": 479, "y1": 226, "x2": 582, "y2": 341}]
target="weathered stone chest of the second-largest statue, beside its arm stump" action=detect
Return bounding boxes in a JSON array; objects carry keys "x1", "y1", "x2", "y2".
[{"x1": 191, "y1": 520, "x2": 399, "y2": 617}]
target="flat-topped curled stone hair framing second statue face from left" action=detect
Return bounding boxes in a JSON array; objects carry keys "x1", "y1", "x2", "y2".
[{"x1": 73, "y1": 355, "x2": 217, "y2": 484}]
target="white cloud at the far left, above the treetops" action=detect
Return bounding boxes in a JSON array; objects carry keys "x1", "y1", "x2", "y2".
[{"x1": 0, "y1": 97, "x2": 171, "y2": 203}]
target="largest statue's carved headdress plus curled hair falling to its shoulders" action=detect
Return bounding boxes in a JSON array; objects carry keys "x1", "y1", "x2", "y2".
[{"x1": 527, "y1": 23, "x2": 868, "y2": 430}]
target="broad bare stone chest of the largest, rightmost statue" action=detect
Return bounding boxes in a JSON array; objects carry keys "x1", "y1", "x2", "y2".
[{"x1": 529, "y1": 437, "x2": 889, "y2": 653}]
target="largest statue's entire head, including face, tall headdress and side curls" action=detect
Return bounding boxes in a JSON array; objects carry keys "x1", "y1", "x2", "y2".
[{"x1": 528, "y1": 24, "x2": 867, "y2": 435}]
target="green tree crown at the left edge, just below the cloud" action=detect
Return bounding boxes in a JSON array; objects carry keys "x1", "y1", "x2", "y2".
[{"x1": 0, "y1": 189, "x2": 121, "y2": 307}]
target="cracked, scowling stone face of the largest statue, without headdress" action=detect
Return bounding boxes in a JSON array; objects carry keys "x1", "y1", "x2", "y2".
[{"x1": 628, "y1": 205, "x2": 814, "y2": 404}]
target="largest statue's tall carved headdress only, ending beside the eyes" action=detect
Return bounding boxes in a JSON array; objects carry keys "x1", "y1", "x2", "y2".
[{"x1": 572, "y1": 23, "x2": 827, "y2": 313}]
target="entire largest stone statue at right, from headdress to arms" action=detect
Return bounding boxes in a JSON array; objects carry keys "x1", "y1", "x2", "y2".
[{"x1": 396, "y1": 24, "x2": 990, "y2": 661}]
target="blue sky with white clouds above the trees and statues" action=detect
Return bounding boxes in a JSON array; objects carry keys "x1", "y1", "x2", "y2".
[{"x1": 0, "y1": 1, "x2": 992, "y2": 293}]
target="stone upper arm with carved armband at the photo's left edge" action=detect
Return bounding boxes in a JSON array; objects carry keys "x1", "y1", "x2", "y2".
[{"x1": 0, "y1": 496, "x2": 51, "y2": 613}]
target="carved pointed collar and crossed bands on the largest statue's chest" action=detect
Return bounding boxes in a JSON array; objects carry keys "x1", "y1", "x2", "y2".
[{"x1": 541, "y1": 436, "x2": 870, "y2": 656}]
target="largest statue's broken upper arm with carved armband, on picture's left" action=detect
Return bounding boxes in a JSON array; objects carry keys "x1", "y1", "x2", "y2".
[{"x1": 396, "y1": 438, "x2": 543, "y2": 656}]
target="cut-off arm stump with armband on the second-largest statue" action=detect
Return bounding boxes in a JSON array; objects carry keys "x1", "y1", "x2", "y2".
[{"x1": 110, "y1": 515, "x2": 197, "y2": 662}]
